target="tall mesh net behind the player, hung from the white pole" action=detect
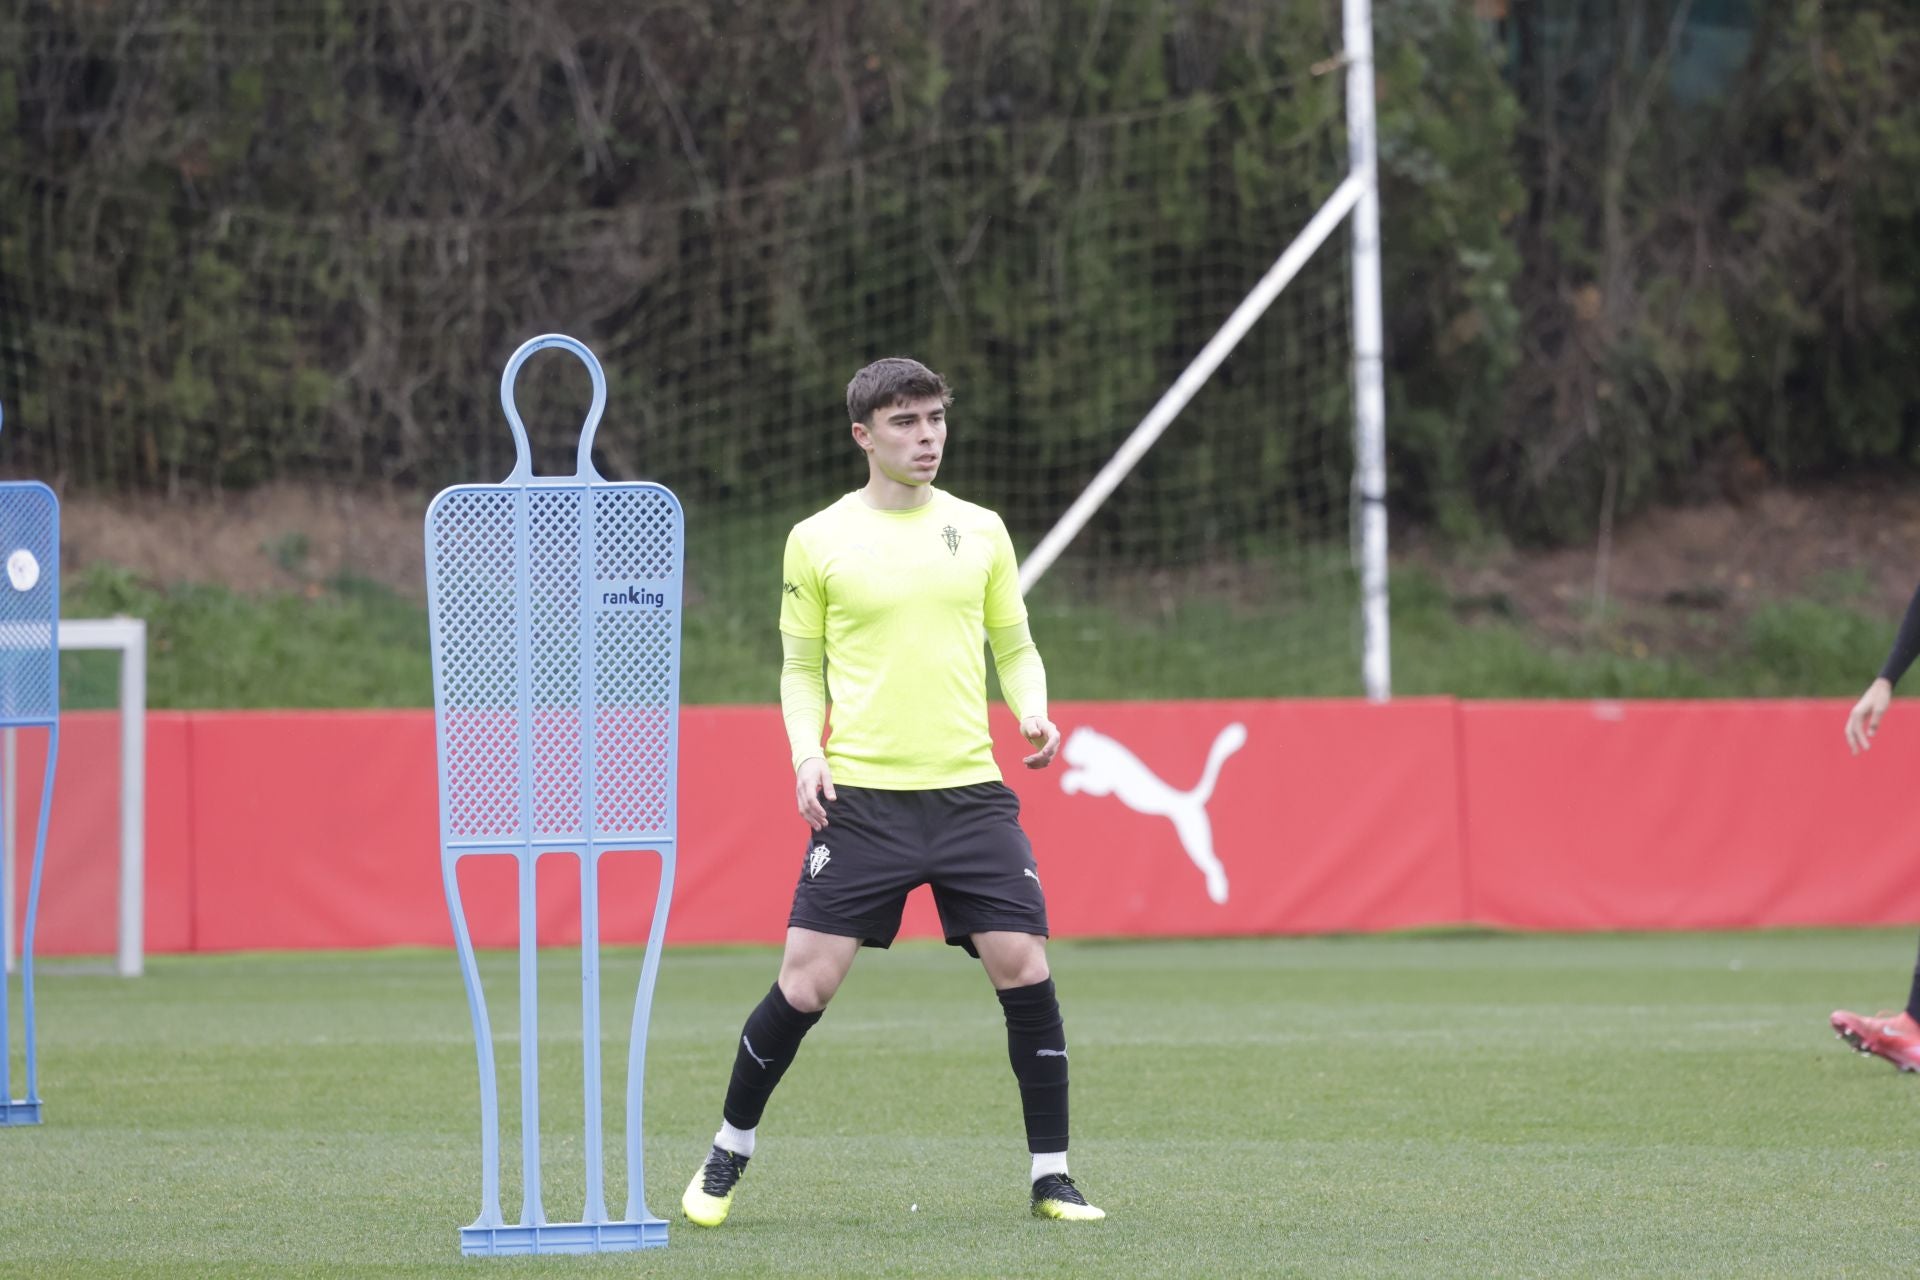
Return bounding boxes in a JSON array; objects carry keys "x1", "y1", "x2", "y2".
[{"x1": 0, "y1": 2, "x2": 1361, "y2": 702}]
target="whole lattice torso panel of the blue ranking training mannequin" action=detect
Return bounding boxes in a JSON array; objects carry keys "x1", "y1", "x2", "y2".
[{"x1": 428, "y1": 470, "x2": 682, "y2": 839}]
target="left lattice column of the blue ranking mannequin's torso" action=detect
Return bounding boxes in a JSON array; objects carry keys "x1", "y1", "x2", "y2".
[{"x1": 428, "y1": 489, "x2": 522, "y2": 839}]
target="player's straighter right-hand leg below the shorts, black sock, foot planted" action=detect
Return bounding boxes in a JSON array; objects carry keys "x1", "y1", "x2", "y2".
[{"x1": 972, "y1": 931, "x2": 1106, "y2": 1221}]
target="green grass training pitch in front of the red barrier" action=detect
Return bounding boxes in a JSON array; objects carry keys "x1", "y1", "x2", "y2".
[{"x1": 0, "y1": 931, "x2": 1920, "y2": 1280}]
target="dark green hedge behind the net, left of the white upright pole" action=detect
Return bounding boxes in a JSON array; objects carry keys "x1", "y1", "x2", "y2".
[{"x1": 0, "y1": 0, "x2": 1348, "y2": 557}]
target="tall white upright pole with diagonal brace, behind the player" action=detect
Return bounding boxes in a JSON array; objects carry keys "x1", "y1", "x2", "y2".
[{"x1": 1020, "y1": 0, "x2": 1392, "y2": 702}]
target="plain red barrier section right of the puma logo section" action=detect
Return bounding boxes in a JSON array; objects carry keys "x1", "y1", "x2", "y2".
[{"x1": 1459, "y1": 700, "x2": 1920, "y2": 929}]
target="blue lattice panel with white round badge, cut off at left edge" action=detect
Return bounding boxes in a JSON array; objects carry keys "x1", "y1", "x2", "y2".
[{"x1": 0, "y1": 484, "x2": 60, "y2": 723}]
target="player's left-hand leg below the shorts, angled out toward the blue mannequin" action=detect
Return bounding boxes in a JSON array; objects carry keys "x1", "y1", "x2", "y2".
[{"x1": 680, "y1": 929, "x2": 860, "y2": 1226}]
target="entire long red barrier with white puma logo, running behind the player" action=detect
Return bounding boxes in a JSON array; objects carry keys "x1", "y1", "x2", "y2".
[{"x1": 12, "y1": 699, "x2": 1920, "y2": 954}]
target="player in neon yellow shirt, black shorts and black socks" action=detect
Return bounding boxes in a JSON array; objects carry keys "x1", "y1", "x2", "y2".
[{"x1": 680, "y1": 359, "x2": 1106, "y2": 1226}]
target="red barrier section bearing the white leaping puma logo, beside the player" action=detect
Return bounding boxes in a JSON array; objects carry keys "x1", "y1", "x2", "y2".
[{"x1": 1029, "y1": 700, "x2": 1463, "y2": 936}]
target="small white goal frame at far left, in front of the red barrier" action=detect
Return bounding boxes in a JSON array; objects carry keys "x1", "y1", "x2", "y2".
[{"x1": 0, "y1": 618, "x2": 146, "y2": 979}]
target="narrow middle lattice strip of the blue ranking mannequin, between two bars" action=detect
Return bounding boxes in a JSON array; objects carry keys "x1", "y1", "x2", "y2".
[{"x1": 526, "y1": 489, "x2": 586, "y2": 837}]
